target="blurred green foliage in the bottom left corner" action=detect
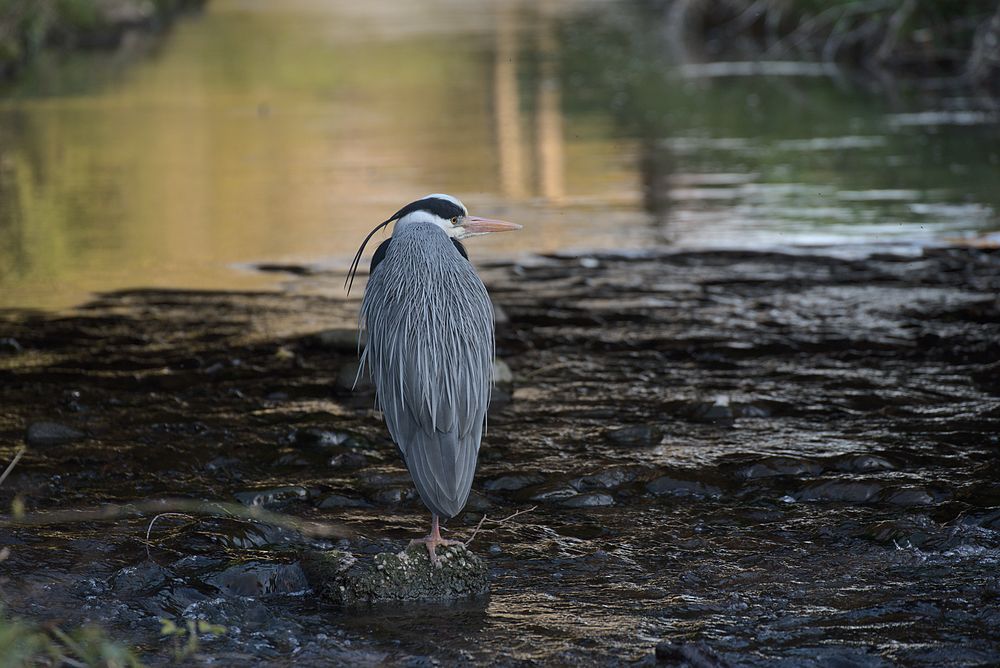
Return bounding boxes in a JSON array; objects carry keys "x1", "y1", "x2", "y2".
[{"x1": 0, "y1": 611, "x2": 142, "y2": 668}]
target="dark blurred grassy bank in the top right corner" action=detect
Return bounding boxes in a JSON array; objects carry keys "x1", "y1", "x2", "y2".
[{"x1": 664, "y1": 0, "x2": 1000, "y2": 84}]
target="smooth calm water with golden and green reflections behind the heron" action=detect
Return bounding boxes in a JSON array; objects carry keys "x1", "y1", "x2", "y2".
[{"x1": 0, "y1": 0, "x2": 1000, "y2": 308}]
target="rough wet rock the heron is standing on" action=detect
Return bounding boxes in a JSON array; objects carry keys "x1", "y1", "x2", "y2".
[{"x1": 302, "y1": 545, "x2": 489, "y2": 605}]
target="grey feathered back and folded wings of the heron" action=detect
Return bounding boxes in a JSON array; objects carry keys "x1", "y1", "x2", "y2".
[{"x1": 362, "y1": 263, "x2": 494, "y2": 517}]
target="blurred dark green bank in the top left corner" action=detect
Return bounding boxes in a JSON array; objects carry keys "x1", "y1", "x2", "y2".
[{"x1": 0, "y1": 0, "x2": 204, "y2": 77}]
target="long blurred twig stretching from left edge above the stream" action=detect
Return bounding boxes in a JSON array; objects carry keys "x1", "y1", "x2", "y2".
[{"x1": 0, "y1": 499, "x2": 354, "y2": 538}]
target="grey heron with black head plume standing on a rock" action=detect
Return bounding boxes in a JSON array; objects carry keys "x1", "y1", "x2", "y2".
[{"x1": 345, "y1": 194, "x2": 521, "y2": 567}]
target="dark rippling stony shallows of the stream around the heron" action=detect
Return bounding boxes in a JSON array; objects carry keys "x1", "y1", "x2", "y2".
[{"x1": 0, "y1": 248, "x2": 1000, "y2": 666}]
